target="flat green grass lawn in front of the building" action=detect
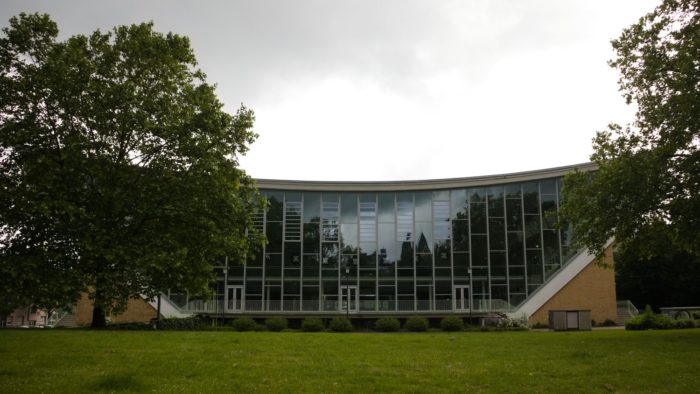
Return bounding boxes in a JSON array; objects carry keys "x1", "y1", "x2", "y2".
[{"x1": 0, "y1": 329, "x2": 700, "y2": 393}]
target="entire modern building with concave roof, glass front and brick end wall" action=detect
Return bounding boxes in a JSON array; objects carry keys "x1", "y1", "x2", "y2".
[{"x1": 61, "y1": 164, "x2": 617, "y2": 324}]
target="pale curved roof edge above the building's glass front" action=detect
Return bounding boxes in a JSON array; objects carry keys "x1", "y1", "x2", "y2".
[{"x1": 255, "y1": 163, "x2": 598, "y2": 191}]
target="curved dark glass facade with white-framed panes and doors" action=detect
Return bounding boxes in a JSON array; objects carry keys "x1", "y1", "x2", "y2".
[{"x1": 176, "y1": 171, "x2": 572, "y2": 314}]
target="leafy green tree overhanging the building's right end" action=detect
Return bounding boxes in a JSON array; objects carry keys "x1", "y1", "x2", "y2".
[{"x1": 561, "y1": 0, "x2": 700, "y2": 256}]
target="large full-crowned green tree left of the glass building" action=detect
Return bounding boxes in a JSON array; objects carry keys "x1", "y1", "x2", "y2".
[{"x1": 0, "y1": 14, "x2": 262, "y2": 326}]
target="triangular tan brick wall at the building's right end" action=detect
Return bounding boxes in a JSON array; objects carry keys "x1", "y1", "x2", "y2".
[{"x1": 530, "y1": 246, "x2": 617, "y2": 324}]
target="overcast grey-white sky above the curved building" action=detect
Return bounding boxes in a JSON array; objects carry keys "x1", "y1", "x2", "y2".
[{"x1": 0, "y1": 0, "x2": 659, "y2": 180}]
